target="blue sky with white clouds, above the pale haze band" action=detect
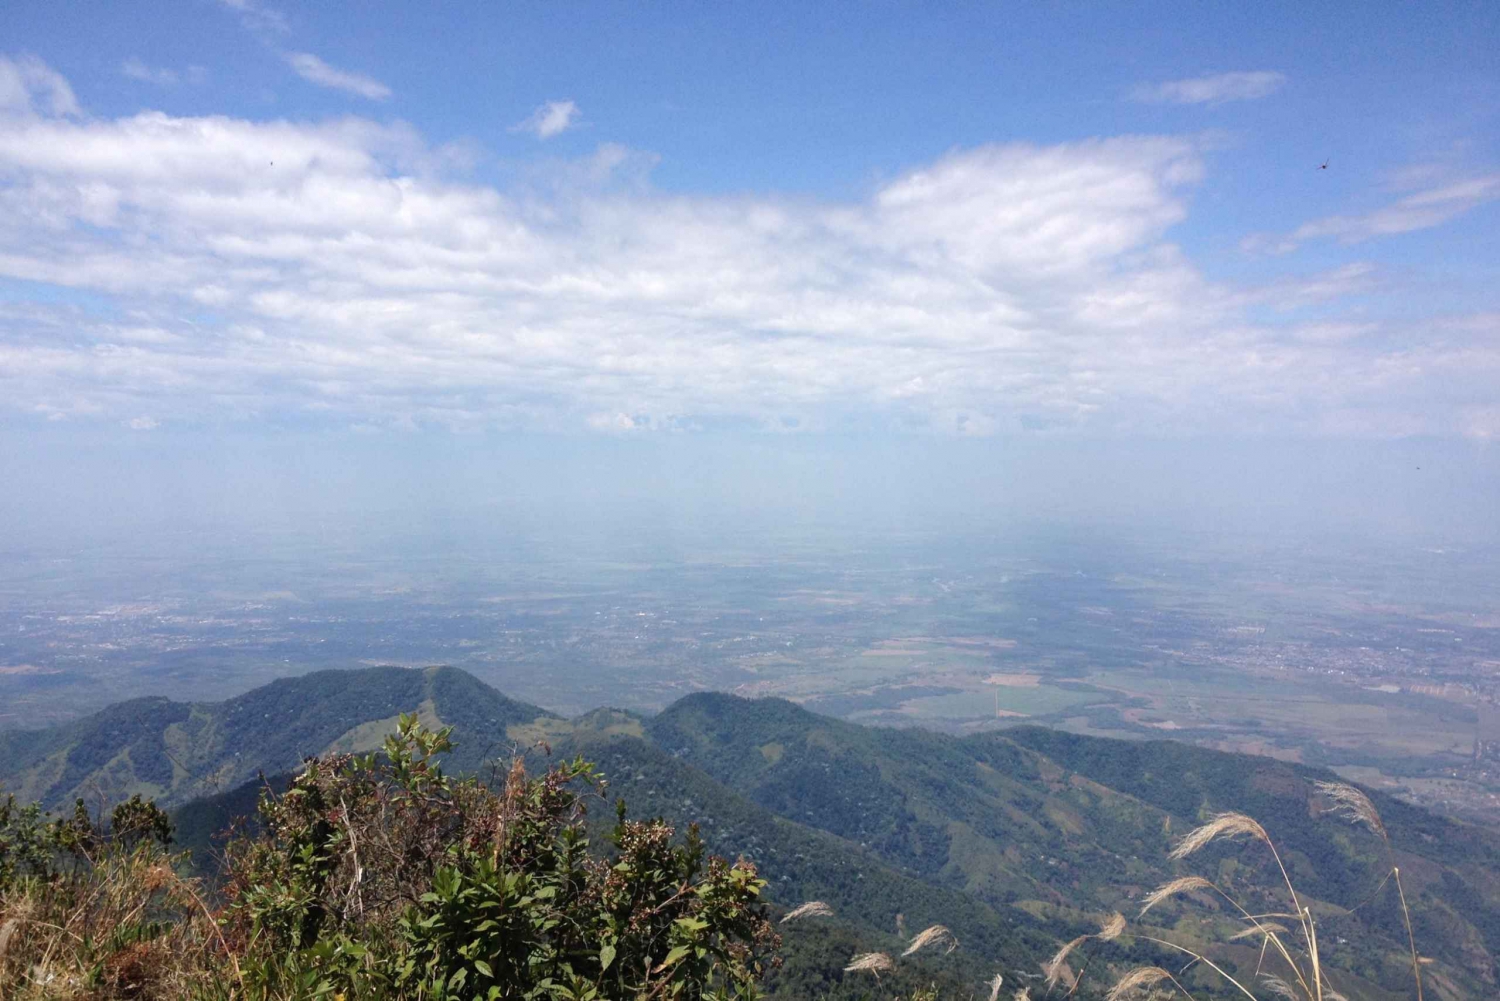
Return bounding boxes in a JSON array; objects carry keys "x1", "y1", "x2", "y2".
[{"x1": 0, "y1": 0, "x2": 1500, "y2": 441}]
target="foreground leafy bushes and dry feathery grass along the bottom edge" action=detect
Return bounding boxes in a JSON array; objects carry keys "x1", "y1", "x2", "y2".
[{"x1": 0, "y1": 716, "x2": 1446, "y2": 1001}]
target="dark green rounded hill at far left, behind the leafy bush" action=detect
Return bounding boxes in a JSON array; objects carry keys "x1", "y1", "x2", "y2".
[{"x1": 0, "y1": 668, "x2": 548, "y2": 809}]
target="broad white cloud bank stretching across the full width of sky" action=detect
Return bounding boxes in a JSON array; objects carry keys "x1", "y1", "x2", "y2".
[{"x1": 0, "y1": 54, "x2": 1500, "y2": 434}]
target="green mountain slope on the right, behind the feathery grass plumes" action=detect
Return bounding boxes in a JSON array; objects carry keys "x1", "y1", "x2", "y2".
[{"x1": 647, "y1": 693, "x2": 1500, "y2": 996}]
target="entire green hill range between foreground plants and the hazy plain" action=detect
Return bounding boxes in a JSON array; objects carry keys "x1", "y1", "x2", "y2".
[{"x1": 0, "y1": 668, "x2": 1500, "y2": 1001}]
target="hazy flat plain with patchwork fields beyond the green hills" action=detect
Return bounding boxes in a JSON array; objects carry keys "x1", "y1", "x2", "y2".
[{"x1": 0, "y1": 516, "x2": 1500, "y2": 822}]
